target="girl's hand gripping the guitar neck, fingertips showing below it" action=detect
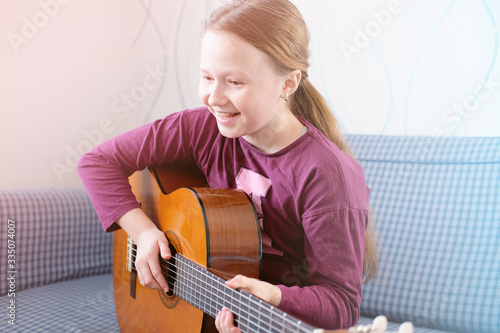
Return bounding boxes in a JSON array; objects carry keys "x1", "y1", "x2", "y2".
[{"x1": 215, "y1": 275, "x2": 281, "y2": 333}]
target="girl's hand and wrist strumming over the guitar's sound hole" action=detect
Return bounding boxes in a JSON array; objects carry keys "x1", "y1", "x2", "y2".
[{"x1": 116, "y1": 208, "x2": 172, "y2": 292}]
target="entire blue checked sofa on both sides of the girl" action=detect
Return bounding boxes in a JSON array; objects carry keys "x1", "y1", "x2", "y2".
[{"x1": 0, "y1": 135, "x2": 500, "y2": 333}]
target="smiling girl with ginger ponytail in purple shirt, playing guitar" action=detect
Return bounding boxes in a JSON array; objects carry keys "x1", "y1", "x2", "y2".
[{"x1": 78, "y1": 0, "x2": 376, "y2": 332}]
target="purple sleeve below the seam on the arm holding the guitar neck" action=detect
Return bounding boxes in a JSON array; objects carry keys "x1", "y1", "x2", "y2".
[{"x1": 278, "y1": 208, "x2": 368, "y2": 329}]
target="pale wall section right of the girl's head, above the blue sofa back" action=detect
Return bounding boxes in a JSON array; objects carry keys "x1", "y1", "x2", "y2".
[{"x1": 296, "y1": 0, "x2": 500, "y2": 136}]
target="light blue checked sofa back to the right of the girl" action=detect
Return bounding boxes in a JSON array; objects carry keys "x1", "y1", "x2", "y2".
[{"x1": 347, "y1": 135, "x2": 500, "y2": 332}]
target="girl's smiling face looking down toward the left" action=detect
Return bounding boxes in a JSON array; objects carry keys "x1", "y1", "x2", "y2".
[{"x1": 199, "y1": 30, "x2": 296, "y2": 150}]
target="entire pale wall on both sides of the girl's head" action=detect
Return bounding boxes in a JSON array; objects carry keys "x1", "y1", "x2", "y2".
[{"x1": 0, "y1": 0, "x2": 500, "y2": 188}]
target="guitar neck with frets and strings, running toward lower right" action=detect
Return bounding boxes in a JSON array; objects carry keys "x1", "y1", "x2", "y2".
[{"x1": 173, "y1": 254, "x2": 322, "y2": 333}]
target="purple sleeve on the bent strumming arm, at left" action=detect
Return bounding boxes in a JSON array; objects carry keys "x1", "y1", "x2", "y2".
[{"x1": 77, "y1": 110, "x2": 211, "y2": 231}]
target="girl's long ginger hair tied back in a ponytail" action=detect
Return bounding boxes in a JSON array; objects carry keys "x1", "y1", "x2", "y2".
[{"x1": 204, "y1": 0, "x2": 377, "y2": 282}]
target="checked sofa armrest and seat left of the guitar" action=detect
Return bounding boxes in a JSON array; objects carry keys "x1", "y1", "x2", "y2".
[{"x1": 0, "y1": 188, "x2": 115, "y2": 333}]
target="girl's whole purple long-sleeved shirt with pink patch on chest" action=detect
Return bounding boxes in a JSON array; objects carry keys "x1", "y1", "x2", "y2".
[{"x1": 78, "y1": 108, "x2": 369, "y2": 329}]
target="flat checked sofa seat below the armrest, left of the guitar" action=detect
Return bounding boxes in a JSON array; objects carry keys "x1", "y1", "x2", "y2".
[{"x1": 0, "y1": 274, "x2": 120, "y2": 333}]
